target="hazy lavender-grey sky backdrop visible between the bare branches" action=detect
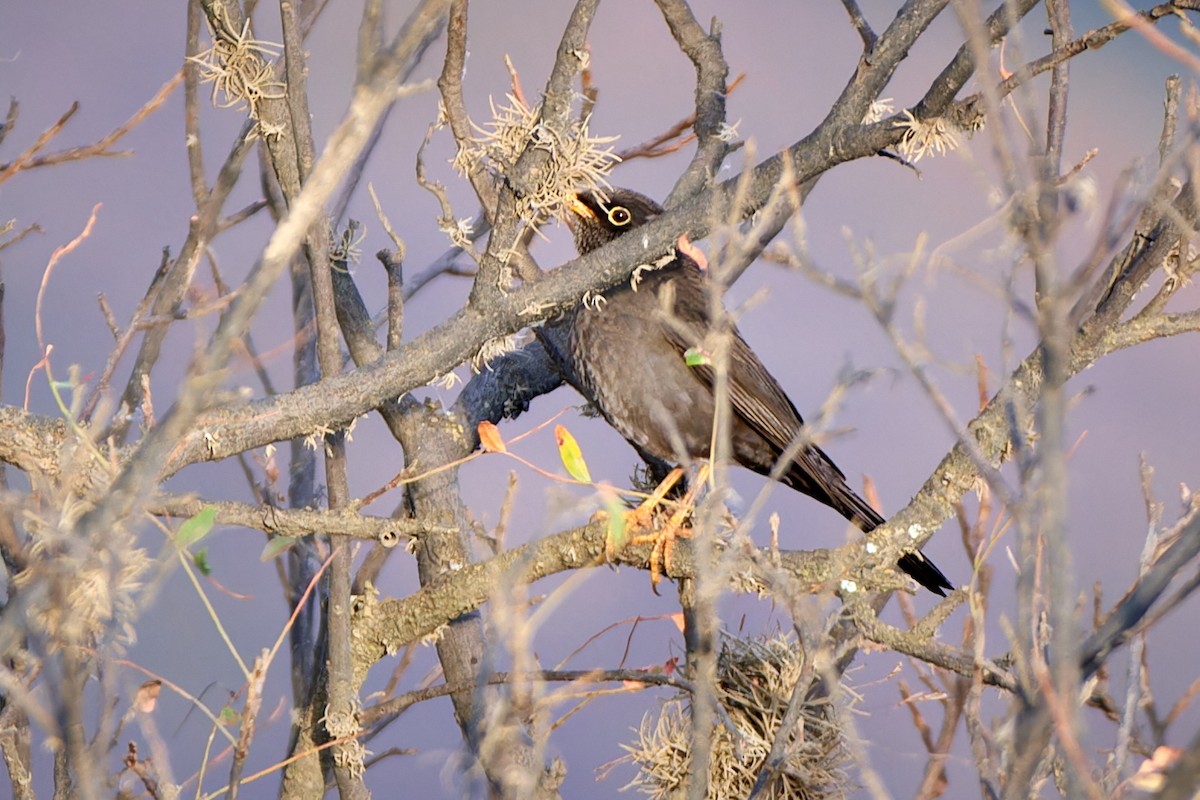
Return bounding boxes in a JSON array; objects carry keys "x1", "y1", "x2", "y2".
[{"x1": 0, "y1": 0, "x2": 1200, "y2": 798}]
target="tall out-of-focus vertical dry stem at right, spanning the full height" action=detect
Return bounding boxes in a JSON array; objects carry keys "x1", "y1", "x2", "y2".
[{"x1": 998, "y1": 1, "x2": 1094, "y2": 786}]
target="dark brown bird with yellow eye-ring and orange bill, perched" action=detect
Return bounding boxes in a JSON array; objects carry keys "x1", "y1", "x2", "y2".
[{"x1": 566, "y1": 188, "x2": 953, "y2": 596}]
